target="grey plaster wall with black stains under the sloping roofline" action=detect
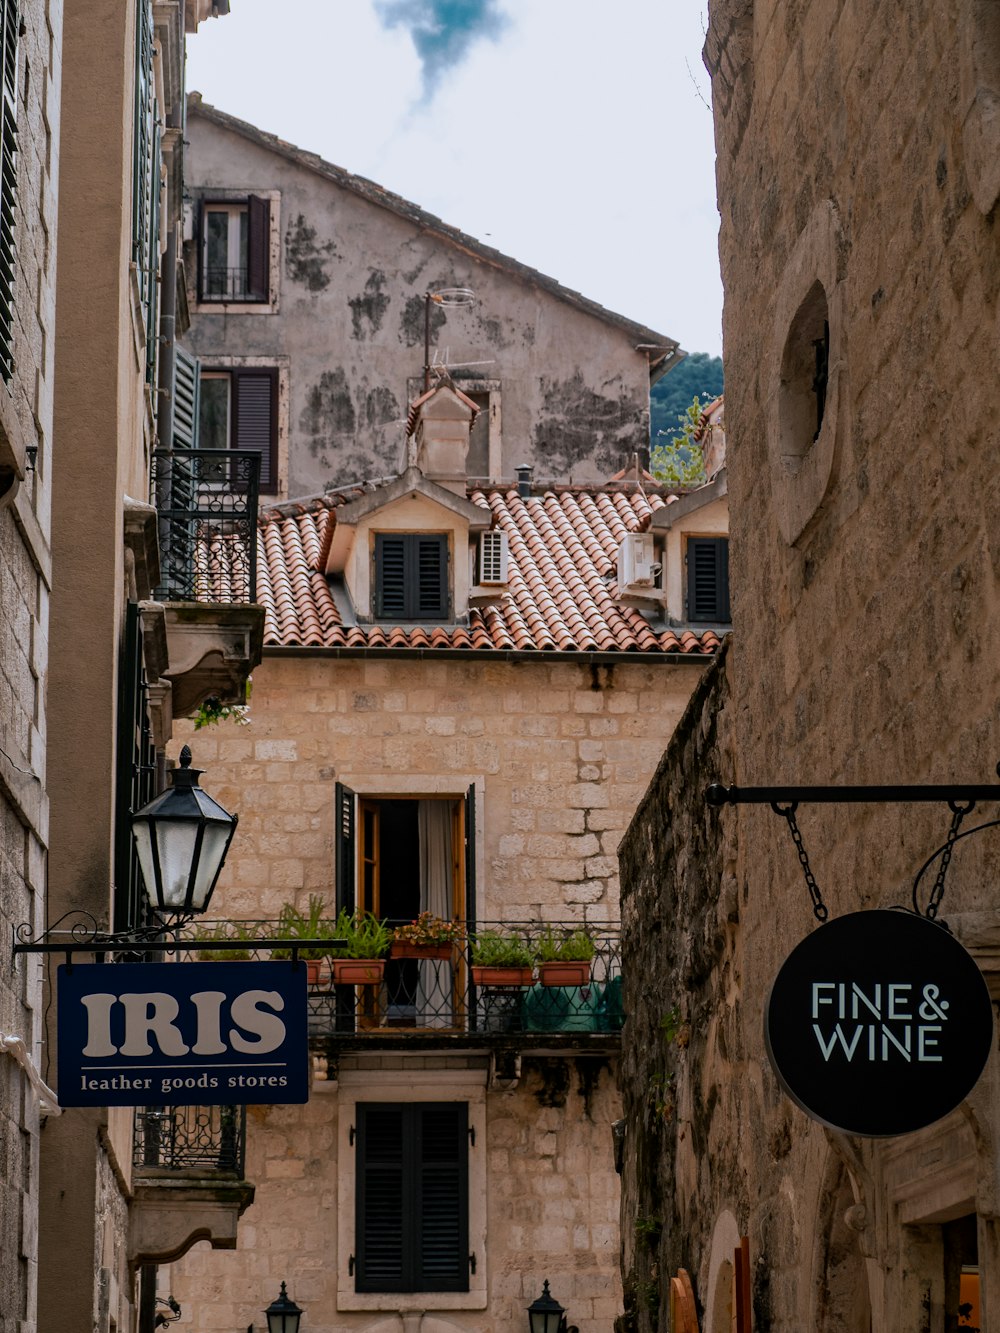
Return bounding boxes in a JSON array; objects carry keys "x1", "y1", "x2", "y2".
[{"x1": 187, "y1": 108, "x2": 666, "y2": 496}]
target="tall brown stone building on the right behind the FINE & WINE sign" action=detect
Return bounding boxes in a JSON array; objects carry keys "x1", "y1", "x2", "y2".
[{"x1": 623, "y1": 0, "x2": 1000, "y2": 1333}]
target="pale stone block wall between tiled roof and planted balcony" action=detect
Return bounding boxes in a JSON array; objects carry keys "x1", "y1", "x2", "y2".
[{"x1": 177, "y1": 653, "x2": 703, "y2": 921}]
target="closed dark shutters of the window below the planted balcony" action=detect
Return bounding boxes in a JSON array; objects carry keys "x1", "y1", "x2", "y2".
[{"x1": 355, "y1": 1101, "x2": 469, "y2": 1292}]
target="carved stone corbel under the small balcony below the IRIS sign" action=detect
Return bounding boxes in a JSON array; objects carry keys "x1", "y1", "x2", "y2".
[{"x1": 128, "y1": 1172, "x2": 253, "y2": 1265}]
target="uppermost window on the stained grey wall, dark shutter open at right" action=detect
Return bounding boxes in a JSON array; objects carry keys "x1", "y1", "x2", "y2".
[{"x1": 199, "y1": 195, "x2": 271, "y2": 304}]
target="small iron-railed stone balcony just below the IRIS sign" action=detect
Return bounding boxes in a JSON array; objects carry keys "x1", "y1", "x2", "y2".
[{"x1": 129, "y1": 1106, "x2": 253, "y2": 1264}]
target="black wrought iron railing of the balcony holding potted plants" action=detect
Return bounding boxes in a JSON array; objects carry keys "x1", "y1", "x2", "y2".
[{"x1": 178, "y1": 921, "x2": 624, "y2": 1040}]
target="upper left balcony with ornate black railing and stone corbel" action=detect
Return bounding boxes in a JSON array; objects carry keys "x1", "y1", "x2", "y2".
[{"x1": 151, "y1": 449, "x2": 264, "y2": 729}]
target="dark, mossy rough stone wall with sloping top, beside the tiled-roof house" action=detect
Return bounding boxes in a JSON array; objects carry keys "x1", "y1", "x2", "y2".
[{"x1": 616, "y1": 649, "x2": 741, "y2": 1333}]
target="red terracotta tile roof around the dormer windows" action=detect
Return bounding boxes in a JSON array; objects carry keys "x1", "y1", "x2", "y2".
[{"x1": 250, "y1": 484, "x2": 719, "y2": 656}]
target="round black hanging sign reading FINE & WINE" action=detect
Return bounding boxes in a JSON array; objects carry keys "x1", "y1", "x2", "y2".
[{"x1": 764, "y1": 909, "x2": 993, "y2": 1138}]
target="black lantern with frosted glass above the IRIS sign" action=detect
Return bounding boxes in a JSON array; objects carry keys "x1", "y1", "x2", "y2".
[{"x1": 132, "y1": 745, "x2": 237, "y2": 922}]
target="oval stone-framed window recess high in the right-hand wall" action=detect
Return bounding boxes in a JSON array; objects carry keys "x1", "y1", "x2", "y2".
[{"x1": 765, "y1": 199, "x2": 851, "y2": 545}]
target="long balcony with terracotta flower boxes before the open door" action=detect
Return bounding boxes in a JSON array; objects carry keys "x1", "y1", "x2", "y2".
[{"x1": 184, "y1": 921, "x2": 624, "y2": 1054}]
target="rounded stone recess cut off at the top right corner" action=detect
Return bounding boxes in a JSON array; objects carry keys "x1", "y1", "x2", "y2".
[{"x1": 959, "y1": 0, "x2": 1000, "y2": 213}]
